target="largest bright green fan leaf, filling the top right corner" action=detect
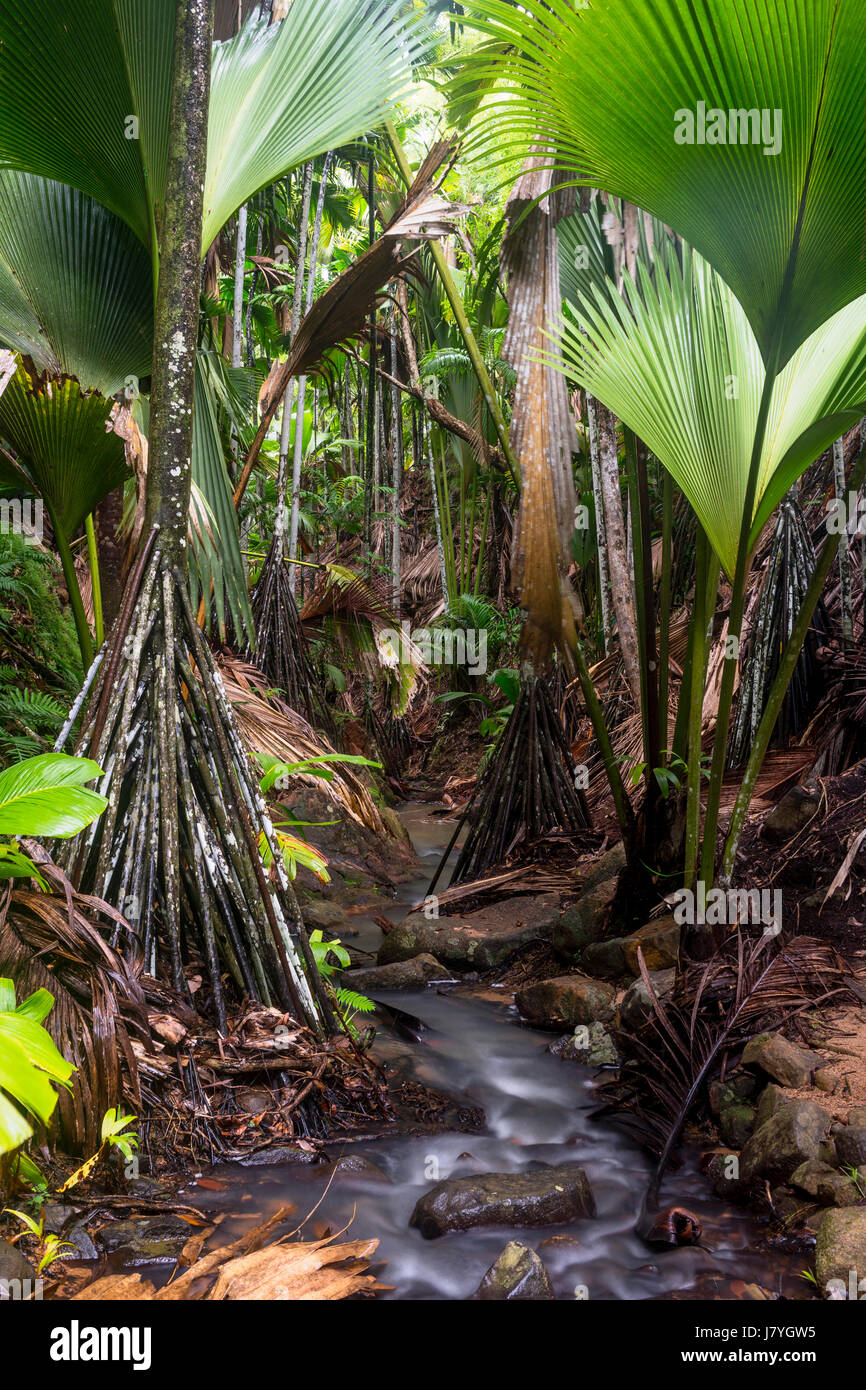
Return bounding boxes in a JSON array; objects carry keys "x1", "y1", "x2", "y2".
[{"x1": 456, "y1": 0, "x2": 866, "y2": 367}]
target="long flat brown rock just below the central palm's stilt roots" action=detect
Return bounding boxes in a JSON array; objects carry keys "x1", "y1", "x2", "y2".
[{"x1": 377, "y1": 892, "x2": 560, "y2": 970}]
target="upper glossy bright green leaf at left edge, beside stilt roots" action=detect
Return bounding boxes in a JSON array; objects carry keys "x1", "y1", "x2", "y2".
[{"x1": 0, "y1": 753, "x2": 107, "y2": 840}]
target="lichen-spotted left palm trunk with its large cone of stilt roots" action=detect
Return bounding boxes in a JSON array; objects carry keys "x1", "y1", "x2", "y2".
[{"x1": 55, "y1": 0, "x2": 335, "y2": 1033}]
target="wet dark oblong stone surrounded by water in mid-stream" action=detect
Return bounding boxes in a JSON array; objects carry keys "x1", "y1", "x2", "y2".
[{"x1": 409, "y1": 1163, "x2": 595, "y2": 1240}]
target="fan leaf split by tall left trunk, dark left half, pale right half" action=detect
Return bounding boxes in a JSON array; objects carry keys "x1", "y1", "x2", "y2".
[{"x1": 0, "y1": 0, "x2": 410, "y2": 261}]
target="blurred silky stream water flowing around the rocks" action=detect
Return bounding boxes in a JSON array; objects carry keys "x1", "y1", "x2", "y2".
[{"x1": 189, "y1": 805, "x2": 808, "y2": 1300}]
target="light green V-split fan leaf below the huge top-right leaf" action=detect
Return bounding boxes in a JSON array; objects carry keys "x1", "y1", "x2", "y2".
[{"x1": 555, "y1": 247, "x2": 866, "y2": 575}]
